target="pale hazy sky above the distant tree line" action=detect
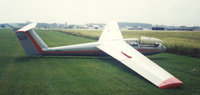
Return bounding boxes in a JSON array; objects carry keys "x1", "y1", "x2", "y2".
[{"x1": 0, "y1": 0, "x2": 200, "y2": 26}]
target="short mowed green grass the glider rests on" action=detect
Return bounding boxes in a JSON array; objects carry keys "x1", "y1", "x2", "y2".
[{"x1": 0, "y1": 29, "x2": 200, "y2": 95}]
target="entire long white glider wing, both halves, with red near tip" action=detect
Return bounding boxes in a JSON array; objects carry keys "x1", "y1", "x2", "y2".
[{"x1": 97, "y1": 21, "x2": 183, "y2": 89}]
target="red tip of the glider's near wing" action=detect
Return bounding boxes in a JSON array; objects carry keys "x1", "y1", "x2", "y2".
[{"x1": 158, "y1": 77, "x2": 183, "y2": 89}]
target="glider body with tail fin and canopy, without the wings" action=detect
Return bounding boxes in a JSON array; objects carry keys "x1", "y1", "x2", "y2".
[{"x1": 16, "y1": 25, "x2": 166, "y2": 56}]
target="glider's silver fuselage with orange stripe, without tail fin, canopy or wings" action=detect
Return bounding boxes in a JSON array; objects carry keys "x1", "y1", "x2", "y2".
[{"x1": 38, "y1": 42, "x2": 166, "y2": 56}]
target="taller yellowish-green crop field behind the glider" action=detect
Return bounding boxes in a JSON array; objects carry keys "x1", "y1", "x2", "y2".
[{"x1": 56, "y1": 30, "x2": 200, "y2": 58}]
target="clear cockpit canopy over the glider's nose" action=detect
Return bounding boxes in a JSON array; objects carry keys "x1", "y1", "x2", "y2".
[{"x1": 124, "y1": 37, "x2": 164, "y2": 47}]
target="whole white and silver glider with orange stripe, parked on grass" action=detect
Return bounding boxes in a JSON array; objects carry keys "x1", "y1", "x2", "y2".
[{"x1": 14, "y1": 21, "x2": 183, "y2": 89}]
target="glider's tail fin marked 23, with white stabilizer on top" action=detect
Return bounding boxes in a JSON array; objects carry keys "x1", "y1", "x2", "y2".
[{"x1": 15, "y1": 23, "x2": 48, "y2": 55}]
